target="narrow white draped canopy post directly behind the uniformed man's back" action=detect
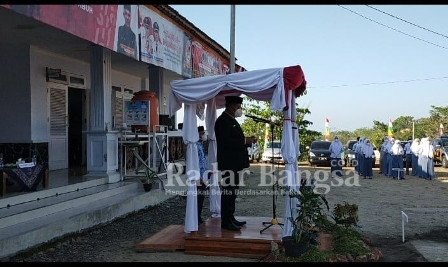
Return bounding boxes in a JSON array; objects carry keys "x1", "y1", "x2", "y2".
[{"x1": 205, "y1": 98, "x2": 221, "y2": 218}]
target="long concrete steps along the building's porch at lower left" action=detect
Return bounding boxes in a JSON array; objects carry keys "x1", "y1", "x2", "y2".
[{"x1": 0, "y1": 173, "x2": 186, "y2": 261}]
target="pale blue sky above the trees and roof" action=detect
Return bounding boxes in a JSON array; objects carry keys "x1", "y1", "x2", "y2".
[{"x1": 170, "y1": 5, "x2": 448, "y2": 132}]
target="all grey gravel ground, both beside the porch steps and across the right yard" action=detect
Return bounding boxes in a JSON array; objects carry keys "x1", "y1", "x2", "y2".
[{"x1": 10, "y1": 163, "x2": 448, "y2": 262}]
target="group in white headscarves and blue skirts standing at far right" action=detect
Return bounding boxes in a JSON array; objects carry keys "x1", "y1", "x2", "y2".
[{"x1": 380, "y1": 137, "x2": 435, "y2": 180}]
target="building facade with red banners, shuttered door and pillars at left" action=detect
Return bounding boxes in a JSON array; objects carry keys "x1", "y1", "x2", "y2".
[{"x1": 0, "y1": 5, "x2": 242, "y2": 196}]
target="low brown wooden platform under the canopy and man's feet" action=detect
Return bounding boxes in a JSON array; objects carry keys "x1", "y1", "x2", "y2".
[{"x1": 136, "y1": 217, "x2": 283, "y2": 259}]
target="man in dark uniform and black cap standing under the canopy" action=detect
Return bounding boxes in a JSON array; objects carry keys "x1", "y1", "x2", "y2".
[{"x1": 215, "y1": 96, "x2": 254, "y2": 231}]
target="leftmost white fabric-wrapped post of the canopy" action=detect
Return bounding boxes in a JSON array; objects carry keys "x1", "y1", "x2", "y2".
[{"x1": 182, "y1": 104, "x2": 199, "y2": 233}]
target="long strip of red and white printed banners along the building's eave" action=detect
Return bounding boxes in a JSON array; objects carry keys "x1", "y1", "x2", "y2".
[{"x1": 0, "y1": 5, "x2": 244, "y2": 78}]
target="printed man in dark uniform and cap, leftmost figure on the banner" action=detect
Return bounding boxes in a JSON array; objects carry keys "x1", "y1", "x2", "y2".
[{"x1": 117, "y1": 5, "x2": 137, "y2": 58}]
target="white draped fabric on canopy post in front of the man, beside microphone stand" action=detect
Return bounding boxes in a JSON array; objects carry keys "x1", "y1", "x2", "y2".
[{"x1": 280, "y1": 90, "x2": 298, "y2": 236}]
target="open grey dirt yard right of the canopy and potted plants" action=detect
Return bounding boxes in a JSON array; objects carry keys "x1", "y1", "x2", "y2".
[{"x1": 266, "y1": 162, "x2": 448, "y2": 262}]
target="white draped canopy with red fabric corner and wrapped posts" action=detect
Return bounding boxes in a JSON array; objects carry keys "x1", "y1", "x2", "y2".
[{"x1": 169, "y1": 65, "x2": 306, "y2": 236}]
